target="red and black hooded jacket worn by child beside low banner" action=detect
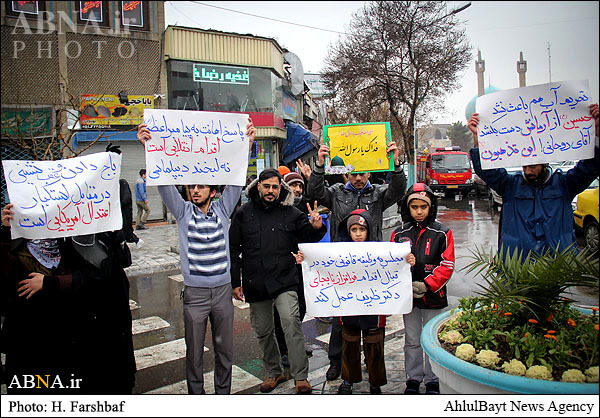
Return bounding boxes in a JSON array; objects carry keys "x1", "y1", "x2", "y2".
[{"x1": 391, "y1": 183, "x2": 454, "y2": 309}]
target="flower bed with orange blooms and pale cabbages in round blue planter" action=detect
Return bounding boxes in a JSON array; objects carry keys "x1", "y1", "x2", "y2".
[{"x1": 438, "y1": 298, "x2": 598, "y2": 383}]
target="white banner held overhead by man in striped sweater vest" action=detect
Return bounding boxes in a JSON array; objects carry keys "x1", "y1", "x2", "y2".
[{"x1": 144, "y1": 109, "x2": 249, "y2": 186}]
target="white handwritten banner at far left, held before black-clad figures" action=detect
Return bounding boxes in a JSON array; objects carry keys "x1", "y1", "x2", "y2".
[{"x1": 2, "y1": 152, "x2": 123, "y2": 239}]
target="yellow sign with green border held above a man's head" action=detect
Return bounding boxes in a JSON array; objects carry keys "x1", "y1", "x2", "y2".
[{"x1": 323, "y1": 122, "x2": 394, "y2": 174}]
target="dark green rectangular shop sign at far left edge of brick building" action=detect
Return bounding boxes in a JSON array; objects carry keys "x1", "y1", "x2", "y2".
[{"x1": 2, "y1": 107, "x2": 54, "y2": 138}]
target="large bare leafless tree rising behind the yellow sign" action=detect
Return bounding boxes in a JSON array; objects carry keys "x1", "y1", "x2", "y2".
[{"x1": 323, "y1": 1, "x2": 471, "y2": 165}]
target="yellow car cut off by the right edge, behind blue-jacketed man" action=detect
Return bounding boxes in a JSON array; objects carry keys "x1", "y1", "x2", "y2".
[{"x1": 571, "y1": 178, "x2": 599, "y2": 252}]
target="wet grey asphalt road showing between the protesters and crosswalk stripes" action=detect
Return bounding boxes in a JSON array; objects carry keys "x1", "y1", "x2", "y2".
[{"x1": 130, "y1": 193, "x2": 598, "y2": 394}]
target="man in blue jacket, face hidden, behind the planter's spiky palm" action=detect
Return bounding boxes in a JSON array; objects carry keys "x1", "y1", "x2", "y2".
[{"x1": 468, "y1": 104, "x2": 600, "y2": 257}]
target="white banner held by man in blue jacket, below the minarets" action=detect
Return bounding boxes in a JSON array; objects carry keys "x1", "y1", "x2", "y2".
[{"x1": 475, "y1": 80, "x2": 595, "y2": 169}]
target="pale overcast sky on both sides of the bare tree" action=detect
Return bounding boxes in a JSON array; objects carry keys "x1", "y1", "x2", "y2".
[{"x1": 165, "y1": 1, "x2": 600, "y2": 124}]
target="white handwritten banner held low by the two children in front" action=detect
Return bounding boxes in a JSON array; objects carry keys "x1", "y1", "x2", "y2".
[{"x1": 298, "y1": 242, "x2": 413, "y2": 317}]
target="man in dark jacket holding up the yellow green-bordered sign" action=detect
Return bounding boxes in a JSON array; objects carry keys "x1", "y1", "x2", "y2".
[{"x1": 307, "y1": 141, "x2": 406, "y2": 380}]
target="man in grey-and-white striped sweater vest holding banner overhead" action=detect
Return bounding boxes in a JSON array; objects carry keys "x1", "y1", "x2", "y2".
[{"x1": 137, "y1": 119, "x2": 256, "y2": 394}]
